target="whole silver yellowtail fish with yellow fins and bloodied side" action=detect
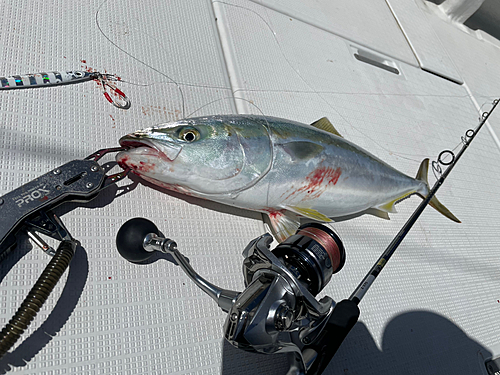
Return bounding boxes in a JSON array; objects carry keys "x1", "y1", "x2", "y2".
[{"x1": 117, "y1": 115, "x2": 460, "y2": 241}]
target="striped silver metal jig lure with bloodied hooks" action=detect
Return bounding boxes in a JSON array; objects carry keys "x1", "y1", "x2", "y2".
[{"x1": 0, "y1": 70, "x2": 130, "y2": 109}]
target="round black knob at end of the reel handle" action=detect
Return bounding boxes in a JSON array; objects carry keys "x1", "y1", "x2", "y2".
[{"x1": 116, "y1": 217, "x2": 160, "y2": 262}]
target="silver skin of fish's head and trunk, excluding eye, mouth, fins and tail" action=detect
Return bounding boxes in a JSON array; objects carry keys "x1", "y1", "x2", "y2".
[{"x1": 122, "y1": 115, "x2": 428, "y2": 217}]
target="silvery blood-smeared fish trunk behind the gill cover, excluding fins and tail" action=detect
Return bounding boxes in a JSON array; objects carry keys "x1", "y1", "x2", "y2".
[{"x1": 222, "y1": 116, "x2": 427, "y2": 217}]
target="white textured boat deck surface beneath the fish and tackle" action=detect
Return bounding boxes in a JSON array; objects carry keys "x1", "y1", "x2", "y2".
[{"x1": 0, "y1": 0, "x2": 500, "y2": 375}]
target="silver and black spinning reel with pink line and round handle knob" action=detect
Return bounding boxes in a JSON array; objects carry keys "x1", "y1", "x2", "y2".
[{"x1": 116, "y1": 218, "x2": 359, "y2": 375}]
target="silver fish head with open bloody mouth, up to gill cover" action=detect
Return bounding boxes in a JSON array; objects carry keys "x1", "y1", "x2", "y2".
[{"x1": 116, "y1": 116, "x2": 272, "y2": 195}]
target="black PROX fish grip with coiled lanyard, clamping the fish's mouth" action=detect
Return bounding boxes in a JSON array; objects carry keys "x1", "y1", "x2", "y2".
[{"x1": 0, "y1": 147, "x2": 128, "y2": 358}]
